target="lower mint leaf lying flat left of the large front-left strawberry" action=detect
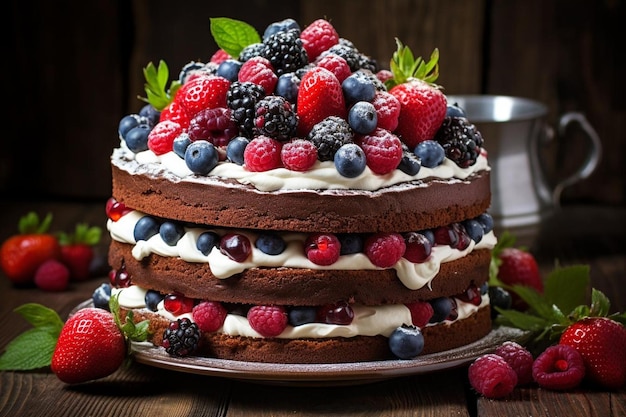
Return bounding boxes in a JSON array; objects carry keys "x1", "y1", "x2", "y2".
[{"x1": 0, "y1": 327, "x2": 57, "y2": 371}]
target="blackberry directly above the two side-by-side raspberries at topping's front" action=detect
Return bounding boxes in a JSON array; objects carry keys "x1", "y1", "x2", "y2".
[{"x1": 254, "y1": 96, "x2": 298, "y2": 141}]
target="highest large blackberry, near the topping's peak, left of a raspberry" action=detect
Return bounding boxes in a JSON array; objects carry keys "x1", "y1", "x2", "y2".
[{"x1": 261, "y1": 29, "x2": 309, "y2": 76}]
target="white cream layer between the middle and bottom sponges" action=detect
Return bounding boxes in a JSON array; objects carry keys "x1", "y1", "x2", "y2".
[{"x1": 112, "y1": 285, "x2": 489, "y2": 339}]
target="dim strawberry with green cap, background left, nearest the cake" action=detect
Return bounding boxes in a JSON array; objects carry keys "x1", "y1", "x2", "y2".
[{"x1": 59, "y1": 223, "x2": 102, "y2": 281}]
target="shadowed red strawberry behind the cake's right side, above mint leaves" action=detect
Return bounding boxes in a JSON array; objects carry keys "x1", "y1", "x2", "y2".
[{"x1": 498, "y1": 247, "x2": 543, "y2": 310}]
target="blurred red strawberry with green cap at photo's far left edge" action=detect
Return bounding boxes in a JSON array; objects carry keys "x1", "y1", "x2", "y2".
[{"x1": 0, "y1": 212, "x2": 61, "y2": 284}]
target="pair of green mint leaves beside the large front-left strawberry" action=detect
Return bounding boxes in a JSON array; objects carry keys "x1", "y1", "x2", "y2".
[{"x1": 0, "y1": 303, "x2": 63, "y2": 371}]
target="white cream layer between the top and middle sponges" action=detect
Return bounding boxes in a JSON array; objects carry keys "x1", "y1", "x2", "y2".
[{"x1": 107, "y1": 210, "x2": 497, "y2": 290}]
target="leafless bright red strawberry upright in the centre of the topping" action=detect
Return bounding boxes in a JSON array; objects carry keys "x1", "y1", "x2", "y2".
[{"x1": 296, "y1": 67, "x2": 346, "y2": 136}]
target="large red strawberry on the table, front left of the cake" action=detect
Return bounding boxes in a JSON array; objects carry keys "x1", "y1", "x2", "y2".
[{"x1": 51, "y1": 308, "x2": 126, "y2": 384}]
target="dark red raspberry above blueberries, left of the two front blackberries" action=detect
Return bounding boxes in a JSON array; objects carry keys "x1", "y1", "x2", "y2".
[{"x1": 188, "y1": 107, "x2": 238, "y2": 146}]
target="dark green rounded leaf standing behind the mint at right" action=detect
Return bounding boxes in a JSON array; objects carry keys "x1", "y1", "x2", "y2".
[{"x1": 543, "y1": 265, "x2": 590, "y2": 312}]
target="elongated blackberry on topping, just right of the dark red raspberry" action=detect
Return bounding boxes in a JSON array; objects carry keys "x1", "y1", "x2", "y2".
[{"x1": 226, "y1": 81, "x2": 265, "y2": 138}]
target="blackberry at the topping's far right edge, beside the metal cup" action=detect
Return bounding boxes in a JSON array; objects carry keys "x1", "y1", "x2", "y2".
[{"x1": 435, "y1": 117, "x2": 483, "y2": 168}]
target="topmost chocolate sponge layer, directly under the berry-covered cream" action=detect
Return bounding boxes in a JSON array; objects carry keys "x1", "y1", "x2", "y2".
[{"x1": 112, "y1": 163, "x2": 491, "y2": 233}]
